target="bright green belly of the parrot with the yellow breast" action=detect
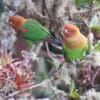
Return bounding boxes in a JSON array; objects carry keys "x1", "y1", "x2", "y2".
[{"x1": 63, "y1": 43, "x2": 86, "y2": 61}]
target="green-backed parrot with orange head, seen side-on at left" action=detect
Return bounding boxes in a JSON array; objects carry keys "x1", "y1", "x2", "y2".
[{"x1": 9, "y1": 15, "x2": 51, "y2": 45}]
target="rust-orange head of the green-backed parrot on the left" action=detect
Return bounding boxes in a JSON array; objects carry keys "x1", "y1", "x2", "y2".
[{"x1": 9, "y1": 15, "x2": 25, "y2": 30}]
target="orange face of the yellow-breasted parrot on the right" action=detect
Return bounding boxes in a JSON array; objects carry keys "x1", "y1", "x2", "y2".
[{"x1": 63, "y1": 24, "x2": 80, "y2": 38}]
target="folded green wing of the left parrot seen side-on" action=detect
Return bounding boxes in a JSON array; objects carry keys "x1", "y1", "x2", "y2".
[{"x1": 20, "y1": 19, "x2": 50, "y2": 42}]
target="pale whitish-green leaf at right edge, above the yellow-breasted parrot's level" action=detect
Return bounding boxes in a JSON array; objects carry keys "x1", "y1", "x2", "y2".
[{"x1": 89, "y1": 14, "x2": 100, "y2": 30}]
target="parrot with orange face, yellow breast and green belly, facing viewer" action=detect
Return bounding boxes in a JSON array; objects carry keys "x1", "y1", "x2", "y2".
[{"x1": 62, "y1": 24, "x2": 88, "y2": 61}]
